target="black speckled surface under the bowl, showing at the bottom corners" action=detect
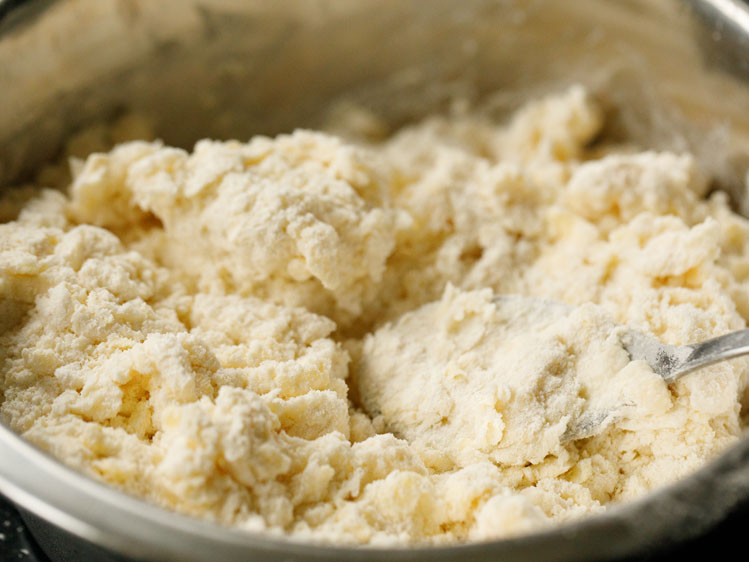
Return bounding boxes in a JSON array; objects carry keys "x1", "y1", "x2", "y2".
[{"x1": 0, "y1": 490, "x2": 749, "y2": 562}]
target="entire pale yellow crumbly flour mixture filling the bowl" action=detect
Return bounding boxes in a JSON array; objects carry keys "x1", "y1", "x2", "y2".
[{"x1": 0, "y1": 87, "x2": 749, "y2": 545}]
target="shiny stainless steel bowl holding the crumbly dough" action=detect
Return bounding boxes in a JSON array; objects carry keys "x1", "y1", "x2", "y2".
[{"x1": 0, "y1": 0, "x2": 749, "y2": 561}]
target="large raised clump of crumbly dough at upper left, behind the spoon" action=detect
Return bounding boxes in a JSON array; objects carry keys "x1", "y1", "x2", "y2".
[{"x1": 71, "y1": 131, "x2": 408, "y2": 315}]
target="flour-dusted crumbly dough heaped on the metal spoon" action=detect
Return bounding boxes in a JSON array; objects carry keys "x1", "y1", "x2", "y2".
[{"x1": 355, "y1": 285, "x2": 671, "y2": 469}]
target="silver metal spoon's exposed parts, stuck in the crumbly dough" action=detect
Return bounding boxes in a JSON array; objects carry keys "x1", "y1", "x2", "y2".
[{"x1": 562, "y1": 328, "x2": 749, "y2": 442}]
